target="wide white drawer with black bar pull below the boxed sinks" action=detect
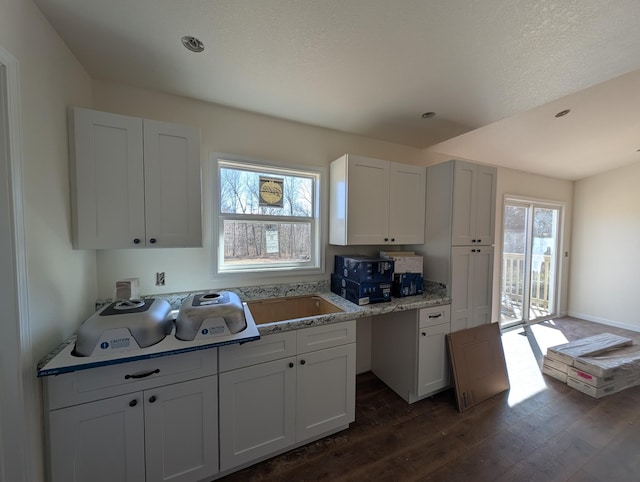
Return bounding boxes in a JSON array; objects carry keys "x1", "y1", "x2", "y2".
[{"x1": 43, "y1": 348, "x2": 218, "y2": 410}]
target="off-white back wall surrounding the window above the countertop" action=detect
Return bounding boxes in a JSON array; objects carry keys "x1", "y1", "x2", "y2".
[{"x1": 93, "y1": 81, "x2": 424, "y2": 298}]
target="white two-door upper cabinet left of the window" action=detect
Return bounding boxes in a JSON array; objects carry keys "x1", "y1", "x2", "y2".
[{"x1": 69, "y1": 108, "x2": 202, "y2": 249}]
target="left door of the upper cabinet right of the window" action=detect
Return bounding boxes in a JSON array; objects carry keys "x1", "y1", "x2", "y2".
[{"x1": 346, "y1": 156, "x2": 389, "y2": 244}]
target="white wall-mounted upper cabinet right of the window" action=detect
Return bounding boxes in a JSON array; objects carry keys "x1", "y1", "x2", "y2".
[{"x1": 329, "y1": 154, "x2": 426, "y2": 246}]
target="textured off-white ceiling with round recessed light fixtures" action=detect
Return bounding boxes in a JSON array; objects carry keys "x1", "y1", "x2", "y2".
[{"x1": 35, "y1": 0, "x2": 640, "y2": 180}]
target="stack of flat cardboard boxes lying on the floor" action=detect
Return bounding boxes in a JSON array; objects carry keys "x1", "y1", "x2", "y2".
[{"x1": 542, "y1": 333, "x2": 640, "y2": 398}]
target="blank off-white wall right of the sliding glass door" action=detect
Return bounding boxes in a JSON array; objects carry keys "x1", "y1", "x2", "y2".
[{"x1": 569, "y1": 158, "x2": 640, "y2": 331}]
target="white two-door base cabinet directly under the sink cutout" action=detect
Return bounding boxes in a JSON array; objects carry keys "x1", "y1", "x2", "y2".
[{"x1": 219, "y1": 320, "x2": 355, "y2": 475}]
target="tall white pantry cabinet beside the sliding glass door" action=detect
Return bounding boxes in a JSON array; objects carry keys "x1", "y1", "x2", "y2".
[{"x1": 425, "y1": 160, "x2": 497, "y2": 332}]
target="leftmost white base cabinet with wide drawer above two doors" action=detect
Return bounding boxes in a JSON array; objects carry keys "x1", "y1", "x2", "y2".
[{"x1": 44, "y1": 349, "x2": 218, "y2": 482}]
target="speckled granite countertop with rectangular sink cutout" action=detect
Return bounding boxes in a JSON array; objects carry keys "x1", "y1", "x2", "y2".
[{"x1": 38, "y1": 281, "x2": 451, "y2": 376}]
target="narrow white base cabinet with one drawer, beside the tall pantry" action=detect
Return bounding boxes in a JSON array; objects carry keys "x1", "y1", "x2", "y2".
[{"x1": 371, "y1": 305, "x2": 451, "y2": 403}]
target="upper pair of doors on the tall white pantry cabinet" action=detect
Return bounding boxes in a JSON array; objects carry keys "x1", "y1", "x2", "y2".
[{"x1": 451, "y1": 161, "x2": 497, "y2": 246}]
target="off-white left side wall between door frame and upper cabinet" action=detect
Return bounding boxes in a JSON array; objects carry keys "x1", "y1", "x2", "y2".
[{"x1": 0, "y1": 0, "x2": 96, "y2": 481}]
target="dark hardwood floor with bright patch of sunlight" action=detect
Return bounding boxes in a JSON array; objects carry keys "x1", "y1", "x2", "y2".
[{"x1": 221, "y1": 317, "x2": 640, "y2": 482}]
